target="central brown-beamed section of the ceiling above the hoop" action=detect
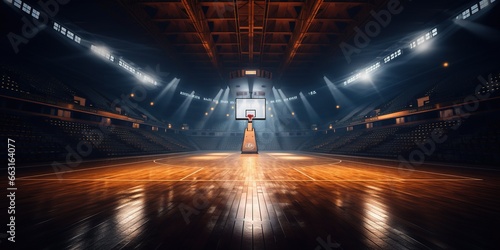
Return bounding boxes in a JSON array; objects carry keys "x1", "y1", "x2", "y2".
[{"x1": 112, "y1": 0, "x2": 387, "y2": 84}]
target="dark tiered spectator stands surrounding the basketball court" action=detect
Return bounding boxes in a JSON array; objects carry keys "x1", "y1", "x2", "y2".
[{"x1": 0, "y1": 66, "x2": 500, "y2": 164}]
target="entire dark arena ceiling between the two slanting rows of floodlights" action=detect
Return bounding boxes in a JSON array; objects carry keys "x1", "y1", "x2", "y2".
[{"x1": 1, "y1": 0, "x2": 486, "y2": 90}]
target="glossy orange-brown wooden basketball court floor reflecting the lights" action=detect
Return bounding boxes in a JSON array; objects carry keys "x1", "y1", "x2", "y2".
[{"x1": 4, "y1": 152, "x2": 500, "y2": 249}]
